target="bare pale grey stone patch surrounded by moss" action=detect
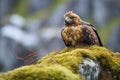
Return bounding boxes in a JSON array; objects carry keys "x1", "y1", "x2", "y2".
[{"x1": 79, "y1": 58, "x2": 100, "y2": 80}]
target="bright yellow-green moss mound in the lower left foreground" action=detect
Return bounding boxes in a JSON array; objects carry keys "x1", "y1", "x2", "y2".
[{"x1": 1, "y1": 65, "x2": 80, "y2": 80}]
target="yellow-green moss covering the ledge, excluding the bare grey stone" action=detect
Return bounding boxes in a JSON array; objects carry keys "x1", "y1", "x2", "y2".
[{"x1": 0, "y1": 46, "x2": 120, "y2": 80}]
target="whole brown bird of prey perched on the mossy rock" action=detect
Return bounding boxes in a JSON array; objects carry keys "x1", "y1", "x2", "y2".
[{"x1": 61, "y1": 11, "x2": 103, "y2": 47}]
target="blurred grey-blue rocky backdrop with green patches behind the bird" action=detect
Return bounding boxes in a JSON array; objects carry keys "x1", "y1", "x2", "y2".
[{"x1": 0, "y1": 0, "x2": 120, "y2": 72}]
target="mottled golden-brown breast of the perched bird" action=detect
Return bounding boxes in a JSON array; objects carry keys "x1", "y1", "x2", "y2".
[{"x1": 62, "y1": 26, "x2": 83, "y2": 46}]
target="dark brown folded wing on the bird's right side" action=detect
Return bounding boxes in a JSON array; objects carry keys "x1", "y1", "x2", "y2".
[{"x1": 82, "y1": 21, "x2": 103, "y2": 46}]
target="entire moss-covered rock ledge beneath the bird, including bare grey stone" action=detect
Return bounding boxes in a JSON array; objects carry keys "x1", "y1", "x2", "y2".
[{"x1": 0, "y1": 46, "x2": 120, "y2": 80}]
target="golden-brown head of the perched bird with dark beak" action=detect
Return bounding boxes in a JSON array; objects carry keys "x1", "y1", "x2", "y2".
[{"x1": 64, "y1": 11, "x2": 81, "y2": 26}]
